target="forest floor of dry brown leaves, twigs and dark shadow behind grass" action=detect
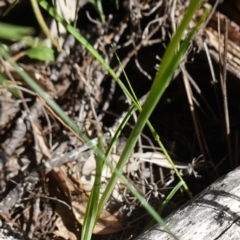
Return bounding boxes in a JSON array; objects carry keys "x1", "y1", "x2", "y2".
[{"x1": 0, "y1": 0, "x2": 240, "y2": 240}]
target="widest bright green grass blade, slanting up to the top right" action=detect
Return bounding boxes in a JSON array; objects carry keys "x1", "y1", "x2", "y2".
[{"x1": 96, "y1": 0, "x2": 207, "y2": 225}]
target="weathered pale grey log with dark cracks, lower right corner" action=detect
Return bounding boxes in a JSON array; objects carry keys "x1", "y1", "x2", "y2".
[{"x1": 136, "y1": 168, "x2": 240, "y2": 240}]
